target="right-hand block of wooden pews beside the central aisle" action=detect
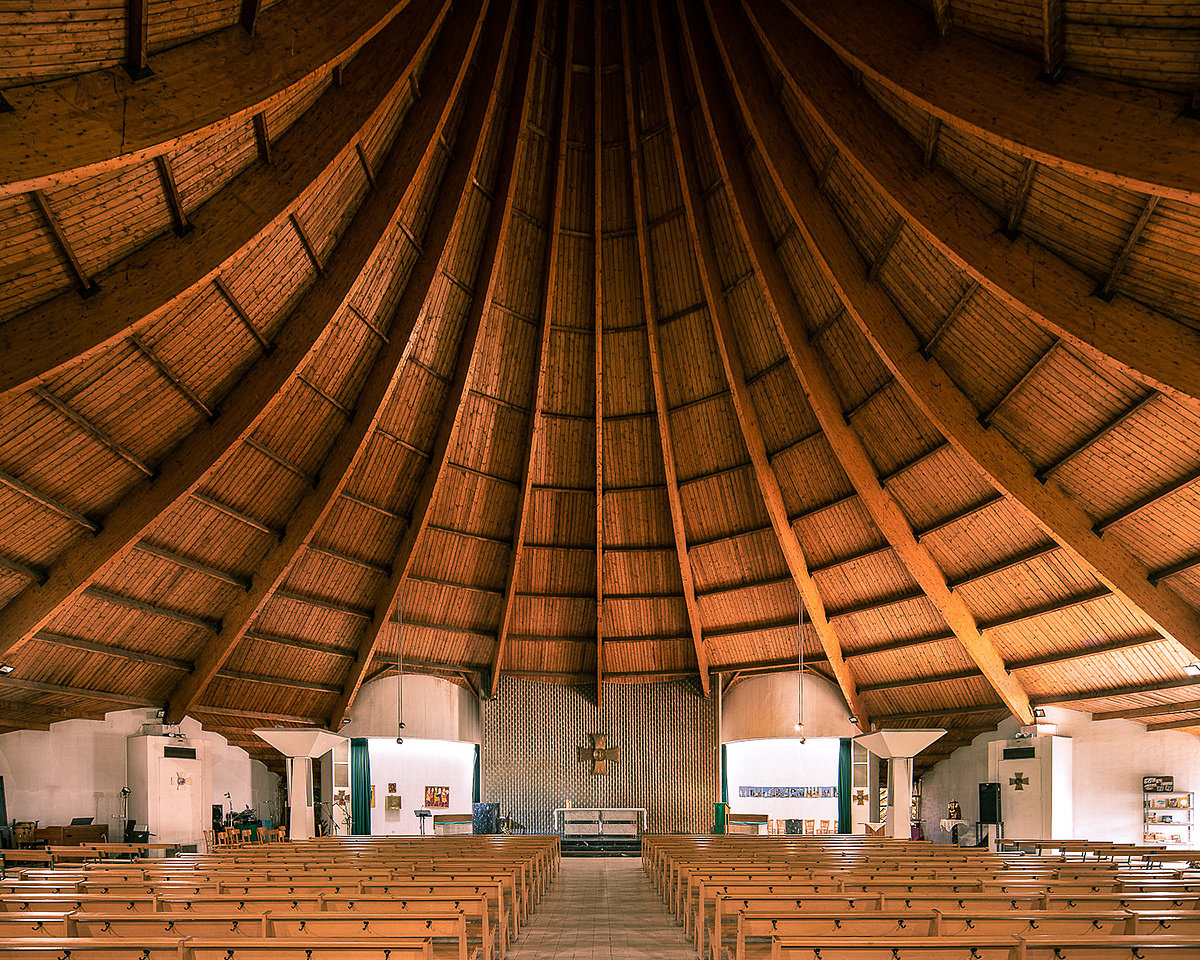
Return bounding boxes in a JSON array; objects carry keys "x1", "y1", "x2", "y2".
[{"x1": 642, "y1": 835, "x2": 1200, "y2": 960}]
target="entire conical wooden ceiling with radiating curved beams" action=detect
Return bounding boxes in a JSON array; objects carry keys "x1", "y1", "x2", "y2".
[{"x1": 0, "y1": 0, "x2": 1200, "y2": 762}]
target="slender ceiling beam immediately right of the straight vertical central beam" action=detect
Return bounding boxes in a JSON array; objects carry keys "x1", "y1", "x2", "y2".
[{"x1": 620, "y1": 4, "x2": 712, "y2": 697}]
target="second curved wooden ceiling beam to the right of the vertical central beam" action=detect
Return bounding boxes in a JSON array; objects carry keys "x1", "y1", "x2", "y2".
[{"x1": 652, "y1": 5, "x2": 866, "y2": 722}]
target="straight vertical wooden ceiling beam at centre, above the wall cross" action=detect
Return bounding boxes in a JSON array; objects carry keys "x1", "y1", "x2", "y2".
[{"x1": 592, "y1": 2, "x2": 605, "y2": 708}]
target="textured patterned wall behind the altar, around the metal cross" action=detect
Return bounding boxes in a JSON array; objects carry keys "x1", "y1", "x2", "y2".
[{"x1": 482, "y1": 677, "x2": 716, "y2": 833}]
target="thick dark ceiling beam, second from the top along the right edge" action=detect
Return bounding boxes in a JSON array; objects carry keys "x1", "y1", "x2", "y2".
[{"x1": 748, "y1": 0, "x2": 1200, "y2": 409}]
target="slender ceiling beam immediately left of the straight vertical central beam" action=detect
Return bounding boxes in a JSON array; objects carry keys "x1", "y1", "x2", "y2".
[{"x1": 488, "y1": 0, "x2": 576, "y2": 697}]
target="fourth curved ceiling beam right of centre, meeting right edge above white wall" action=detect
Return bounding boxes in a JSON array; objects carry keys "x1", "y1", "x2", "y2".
[{"x1": 720, "y1": 0, "x2": 1200, "y2": 653}]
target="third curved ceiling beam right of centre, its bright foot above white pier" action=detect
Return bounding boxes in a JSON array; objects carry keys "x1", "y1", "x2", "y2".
[{"x1": 700, "y1": 5, "x2": 1033, "y2": 722}]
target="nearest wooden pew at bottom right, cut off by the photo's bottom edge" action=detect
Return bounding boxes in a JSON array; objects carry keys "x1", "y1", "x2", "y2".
[{"x1": 770, "y1": 935, "x2": 1200, "y2": 960}]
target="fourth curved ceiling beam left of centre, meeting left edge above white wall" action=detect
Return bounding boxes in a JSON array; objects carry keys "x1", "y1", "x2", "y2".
[{"x1": 0, "y1": 1, "x2": 482, "y2": 676}]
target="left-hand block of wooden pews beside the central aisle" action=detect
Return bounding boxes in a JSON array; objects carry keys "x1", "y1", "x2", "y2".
[{"x1": 0, "y1": 835, "x2": 560, "y2": 960}]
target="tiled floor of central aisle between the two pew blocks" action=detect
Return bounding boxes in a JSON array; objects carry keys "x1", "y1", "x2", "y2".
[{"x1": 509, "y1": 857, "x2": 696, "y2": 960}]
